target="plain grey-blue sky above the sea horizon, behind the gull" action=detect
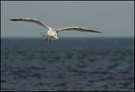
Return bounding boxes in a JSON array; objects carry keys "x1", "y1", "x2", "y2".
[{"x1": 1, "y1": 1, "x2": 134, "y2": 37}]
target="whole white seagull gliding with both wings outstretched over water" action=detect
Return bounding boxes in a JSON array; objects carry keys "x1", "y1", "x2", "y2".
[{"x1": 10, "y1": 18, "x2": 101, "y2": 43}]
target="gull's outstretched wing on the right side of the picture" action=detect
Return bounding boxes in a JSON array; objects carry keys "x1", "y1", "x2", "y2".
[{"x1": 57, "y1": 27, "x2": 101, "y2": 33}]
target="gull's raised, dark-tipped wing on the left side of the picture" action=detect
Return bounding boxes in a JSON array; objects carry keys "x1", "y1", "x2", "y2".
[{"x1": 10, "y1": 18, "x2": 50, "y2": 29}]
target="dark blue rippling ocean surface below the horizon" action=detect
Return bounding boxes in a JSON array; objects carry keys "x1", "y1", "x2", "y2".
[{"x1": 1, "y1": 37, "x2": 134, "y2": 91}]
